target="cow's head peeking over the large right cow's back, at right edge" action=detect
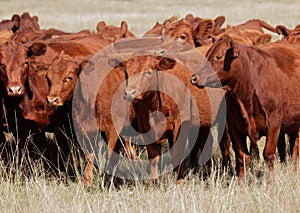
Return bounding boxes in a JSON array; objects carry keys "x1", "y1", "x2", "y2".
[{"x1": 276, "y1": 25, "x2": 300, "y2": 45}]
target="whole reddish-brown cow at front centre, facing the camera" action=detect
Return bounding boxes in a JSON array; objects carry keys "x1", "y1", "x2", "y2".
[{"x1": 113, "y1": 52, "x2": 223, "y2": 184}]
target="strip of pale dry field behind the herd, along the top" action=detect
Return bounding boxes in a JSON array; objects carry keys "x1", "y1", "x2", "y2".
[{"x1": 0, "y1": 0, "x2": 300, "y2": 35}]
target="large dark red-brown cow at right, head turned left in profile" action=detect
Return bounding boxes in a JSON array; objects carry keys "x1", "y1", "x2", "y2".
[{"x1": 191, "y1": 35, "x2": 300, "y2": 180}]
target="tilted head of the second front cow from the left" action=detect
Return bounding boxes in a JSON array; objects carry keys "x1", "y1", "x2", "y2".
[{"x1": 46, "y1": 52, "x2": 90, "y2": 107}]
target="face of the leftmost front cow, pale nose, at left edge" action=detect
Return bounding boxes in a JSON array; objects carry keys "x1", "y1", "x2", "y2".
[{"x1": 0, "y1": 41, "x2": 28, "y2": 96}]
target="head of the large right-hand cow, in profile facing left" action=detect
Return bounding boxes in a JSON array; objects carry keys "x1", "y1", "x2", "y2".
[{"x1": 191, "y1": 35, "x2": 240, "y2": 87}]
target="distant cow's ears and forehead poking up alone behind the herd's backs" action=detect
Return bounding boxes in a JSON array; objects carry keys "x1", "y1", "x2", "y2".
[{"x1": 97, "y1": 21, "x2": 135, "y2": 42}]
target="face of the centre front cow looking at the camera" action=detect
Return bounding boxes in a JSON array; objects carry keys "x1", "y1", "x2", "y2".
[{"x1": 124, "y1": 56, "x2": 176, "y2": 101}]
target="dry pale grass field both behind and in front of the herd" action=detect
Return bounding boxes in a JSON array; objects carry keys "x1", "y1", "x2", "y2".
[{"x1": 0, "y1": 0, "x2": 300, "y2": 212}]
